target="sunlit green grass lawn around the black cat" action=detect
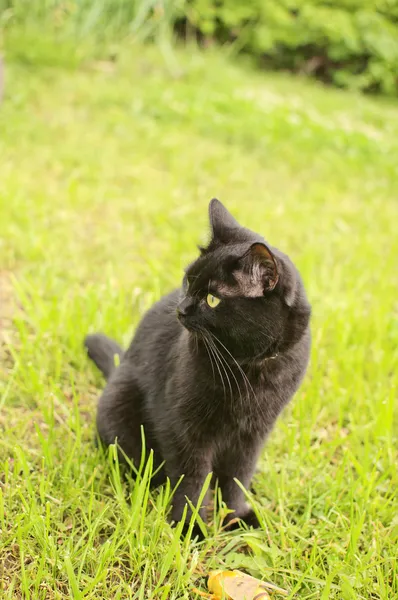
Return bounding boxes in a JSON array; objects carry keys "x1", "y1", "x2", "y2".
[{"x1": 0, "y1": 43, "x2": 398, "y2": 600}]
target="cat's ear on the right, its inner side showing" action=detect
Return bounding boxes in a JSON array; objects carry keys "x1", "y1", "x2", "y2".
[{"x1": 239, "y1": 242, "x2": 279, "y2": 297}]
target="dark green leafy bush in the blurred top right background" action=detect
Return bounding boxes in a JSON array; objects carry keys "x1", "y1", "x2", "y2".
[{"x1": 183, "y1": 0, "x2": 398, "y2": 95}]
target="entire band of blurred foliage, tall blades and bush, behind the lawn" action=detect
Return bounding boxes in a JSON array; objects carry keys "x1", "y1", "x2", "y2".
[{"x1": 0, "y1": 0, "x2": 398, "y2": 95}]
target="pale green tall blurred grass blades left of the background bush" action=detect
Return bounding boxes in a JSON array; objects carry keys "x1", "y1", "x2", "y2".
[{"x1": 0, "y1": 0, "x2": 183, "y2": 66}]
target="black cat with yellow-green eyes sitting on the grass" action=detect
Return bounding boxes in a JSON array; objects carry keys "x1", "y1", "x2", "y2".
[{"x1": 85, "y1": 199, "x2": 311, "y2": 526}]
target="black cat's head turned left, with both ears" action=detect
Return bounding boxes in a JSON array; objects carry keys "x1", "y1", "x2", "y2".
[{"x1": 177, "y1": 199, "x2": 311, "y2": 361}]
